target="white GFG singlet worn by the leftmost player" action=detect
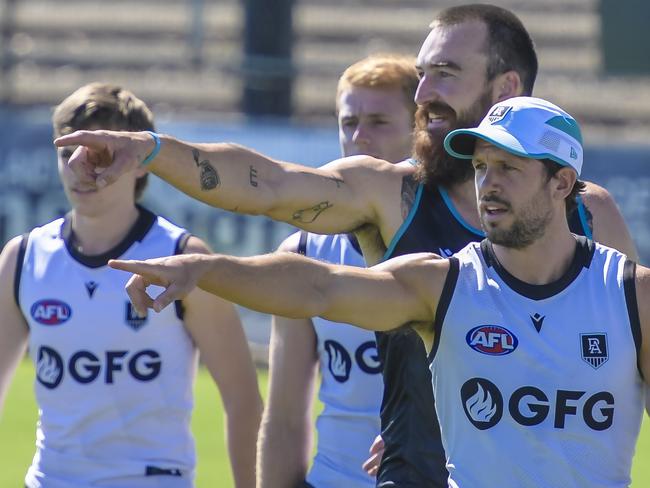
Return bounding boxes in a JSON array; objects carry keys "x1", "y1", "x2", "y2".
[{"x1": 17, "y1": 210, "x2": 197, "y2": 488}]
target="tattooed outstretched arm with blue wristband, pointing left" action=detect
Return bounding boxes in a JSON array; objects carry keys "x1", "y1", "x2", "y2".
[{"x1": 54, "y1": 131, "x2": 412, "y2": 233}]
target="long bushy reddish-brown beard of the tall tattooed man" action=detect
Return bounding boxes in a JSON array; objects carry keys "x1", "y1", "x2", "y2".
[{"x1": 413, "y1": 85, "x2": 493, "y2": 188}]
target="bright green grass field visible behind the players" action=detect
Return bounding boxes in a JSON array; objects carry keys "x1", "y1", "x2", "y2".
[{"x1": 0, "y1": 361, "x2": 650, "y2": 488}]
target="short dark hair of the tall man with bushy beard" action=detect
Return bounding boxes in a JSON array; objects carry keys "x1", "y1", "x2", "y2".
[{"x1": 430, "y1": 4, "x2": 537, "y2": 96}]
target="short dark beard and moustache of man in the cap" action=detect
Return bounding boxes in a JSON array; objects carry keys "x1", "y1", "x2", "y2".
[{"x1": 480, "y1": 188, "x2": 553, "y2": 249}]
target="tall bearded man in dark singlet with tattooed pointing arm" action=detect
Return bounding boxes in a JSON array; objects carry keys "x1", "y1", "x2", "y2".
[{"x1": 55, "y1": 5, "x2": 636, "y2": 487}]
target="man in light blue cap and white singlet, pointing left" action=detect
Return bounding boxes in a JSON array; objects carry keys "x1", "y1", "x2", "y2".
[{"x1": 109, "y1": 97, "x2": 650, "y2": 488}]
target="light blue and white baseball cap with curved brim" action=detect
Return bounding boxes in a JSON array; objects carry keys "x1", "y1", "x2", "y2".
[{"x1": 444, "y1": 97, "x2": 583, "y2": 175}]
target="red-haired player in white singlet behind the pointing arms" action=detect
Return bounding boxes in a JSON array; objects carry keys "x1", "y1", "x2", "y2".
[{"x1": 258, "y1": 55, "x2": 418, "y2": 488}]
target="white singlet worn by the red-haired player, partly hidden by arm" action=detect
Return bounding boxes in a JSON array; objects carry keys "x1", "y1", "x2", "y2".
[{"x1": 288, "y1": 233, "x2": 383, "y2": 488}]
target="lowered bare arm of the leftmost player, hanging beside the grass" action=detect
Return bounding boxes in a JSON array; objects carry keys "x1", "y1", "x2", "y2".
[{"x1": 183, "y1": 237, "x2": 262, "y2": 487}]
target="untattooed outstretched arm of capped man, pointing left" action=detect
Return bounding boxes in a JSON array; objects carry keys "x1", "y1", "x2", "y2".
[{"x1": 109, "y1": 253, "x2": 442, "y2": 331}]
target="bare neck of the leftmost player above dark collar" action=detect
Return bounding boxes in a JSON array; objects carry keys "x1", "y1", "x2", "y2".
[{"x1": 71, "y1": 205, "x2": 139, "y2": 256}]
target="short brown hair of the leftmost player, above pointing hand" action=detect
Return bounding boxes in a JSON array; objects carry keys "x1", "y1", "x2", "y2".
[{"x1": 52, "y1": 82, "x2": 155, "y2": 201}]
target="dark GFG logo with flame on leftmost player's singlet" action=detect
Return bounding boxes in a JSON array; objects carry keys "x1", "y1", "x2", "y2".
[{"x1": 36, "y1": 346, "x2": 162, "y2": 390}]
